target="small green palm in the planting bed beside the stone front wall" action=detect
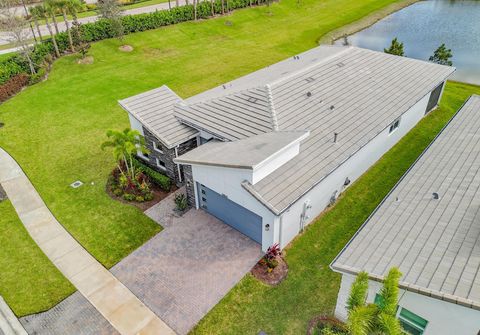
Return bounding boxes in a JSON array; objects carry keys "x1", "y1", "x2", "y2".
[{"x1": 102, "y1": 128, "x2": 148, "y2": 180}]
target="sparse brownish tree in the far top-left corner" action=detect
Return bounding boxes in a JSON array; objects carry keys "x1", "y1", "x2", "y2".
[{"x1": 0, "y1": 0, "x2": 37, "y2": 75}]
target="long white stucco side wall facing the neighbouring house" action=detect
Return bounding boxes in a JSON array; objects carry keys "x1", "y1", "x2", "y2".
[{"x1": 275, "y1": 89, "x2": 436, "y2": 248}]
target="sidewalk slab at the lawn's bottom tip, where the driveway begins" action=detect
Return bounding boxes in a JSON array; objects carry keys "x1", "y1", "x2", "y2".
[{"x1": 70, "y1": 264, "x2": 115, "y2": 296}]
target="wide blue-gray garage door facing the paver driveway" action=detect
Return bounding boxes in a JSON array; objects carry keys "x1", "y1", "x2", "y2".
[{"x1": 197, "y1": 184, "x2": 262, "y2": 243}]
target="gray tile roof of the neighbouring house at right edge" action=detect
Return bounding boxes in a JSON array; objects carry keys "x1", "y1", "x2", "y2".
[{"x1": 332, "y1": 96, "x2": 480, "y2": 307}]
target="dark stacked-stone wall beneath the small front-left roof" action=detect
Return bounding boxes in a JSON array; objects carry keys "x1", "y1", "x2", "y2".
[{"x1": 143, "y1": 127, "x2": 197, "y2": 186}]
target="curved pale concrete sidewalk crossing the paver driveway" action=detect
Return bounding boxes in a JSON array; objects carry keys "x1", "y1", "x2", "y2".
[{"x1": 0, "y1": 148, "x2": 174, "y2": 335}]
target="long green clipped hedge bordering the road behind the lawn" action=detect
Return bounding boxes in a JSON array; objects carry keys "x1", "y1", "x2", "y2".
[{"x1": 0, "y1": 0, "x2": 269, "y2": 85}]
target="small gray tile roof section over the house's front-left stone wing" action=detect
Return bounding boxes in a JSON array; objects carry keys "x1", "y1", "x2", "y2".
[{"x1": 119, "y1": 85, "x2": 198, "y2": 148}]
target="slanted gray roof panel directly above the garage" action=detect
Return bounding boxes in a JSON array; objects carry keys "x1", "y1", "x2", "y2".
[{"x1": 175, "y1": 131, "x2": 308, "y2": 170}]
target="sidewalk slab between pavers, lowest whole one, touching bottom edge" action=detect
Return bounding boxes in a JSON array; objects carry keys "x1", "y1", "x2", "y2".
[{"x1": 107, "y1": 296, "x2": 155, "y2": 335}]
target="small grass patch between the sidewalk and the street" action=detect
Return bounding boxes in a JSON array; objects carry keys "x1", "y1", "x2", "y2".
[{"x1": 0, "y1": 200, "x2": 75, "y2": 316}]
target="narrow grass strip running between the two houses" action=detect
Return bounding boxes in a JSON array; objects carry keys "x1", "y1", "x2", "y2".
[{"x1": 192, "y1": 82, "x2": 480, "y2": 334}]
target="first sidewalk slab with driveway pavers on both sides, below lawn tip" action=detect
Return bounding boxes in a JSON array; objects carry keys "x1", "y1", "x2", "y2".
[{"x1": 86, "y1": 280, "x2": 132, "y2": 321}]
